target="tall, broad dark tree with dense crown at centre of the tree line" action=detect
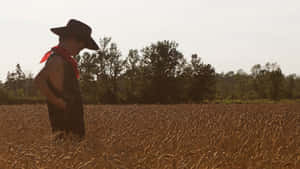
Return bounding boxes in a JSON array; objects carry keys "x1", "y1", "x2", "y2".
[{"x1": 142, "y1": 41, "x2": 184, "y2": 103}]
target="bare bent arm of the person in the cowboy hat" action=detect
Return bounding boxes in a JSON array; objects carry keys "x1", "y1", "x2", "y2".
[{"x1": 34, "y1": 58, "x2": 66, "y2": 110}]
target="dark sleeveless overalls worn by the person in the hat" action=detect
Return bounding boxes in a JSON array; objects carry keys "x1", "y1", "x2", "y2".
[{"x1": 46, "y1": 54, "x2": 85, "y2": 137}]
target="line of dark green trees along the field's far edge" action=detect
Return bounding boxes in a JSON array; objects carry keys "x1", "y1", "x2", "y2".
[{"x1": 0, "y1": 37, "x2": 300, "y2": 104}]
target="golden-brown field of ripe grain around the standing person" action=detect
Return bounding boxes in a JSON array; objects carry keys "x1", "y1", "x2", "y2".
[{"x1": 0, "y1": 104, "x2": 300, "y2": 169}]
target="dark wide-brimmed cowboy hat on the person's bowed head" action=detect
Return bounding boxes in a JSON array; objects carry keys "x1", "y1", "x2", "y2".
[{"x1": 50, "y1": 19, "x2": 99, "y2": 50}]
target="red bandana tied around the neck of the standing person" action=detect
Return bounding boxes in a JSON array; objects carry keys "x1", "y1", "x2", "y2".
[{"x1": 40, "y1": 46, "x2": 79, "y2": 78}]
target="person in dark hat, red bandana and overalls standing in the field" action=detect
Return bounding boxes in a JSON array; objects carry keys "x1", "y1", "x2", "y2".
[{"x1": 35, "y1": 19, "x2": 99, "y2": 139}]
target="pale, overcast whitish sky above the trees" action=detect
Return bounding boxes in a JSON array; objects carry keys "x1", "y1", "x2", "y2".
[{"x1": 0, "y1": 0, "x2": 300, "y2": 81}]
